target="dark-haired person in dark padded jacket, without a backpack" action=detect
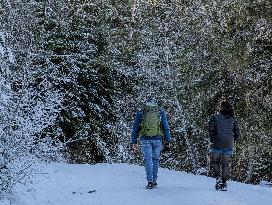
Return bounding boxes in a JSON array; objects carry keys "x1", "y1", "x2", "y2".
[{"x1": 209, "y1": 99, "x2": 240, "y2": 191}]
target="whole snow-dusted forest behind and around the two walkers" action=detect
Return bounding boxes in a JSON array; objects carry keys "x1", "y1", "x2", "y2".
[{"x1": 0, "y1": 0, "x2": 272, "y2": 199}]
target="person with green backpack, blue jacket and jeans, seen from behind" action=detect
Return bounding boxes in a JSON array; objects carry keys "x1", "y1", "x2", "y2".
[{"x1": 131, "y1": 97, "x2": 171, "y2": 189}]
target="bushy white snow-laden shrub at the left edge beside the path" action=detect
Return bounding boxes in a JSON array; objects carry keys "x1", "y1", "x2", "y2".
[{"x1": 0, "y1": 30, "x2": 62, "y2": 198}]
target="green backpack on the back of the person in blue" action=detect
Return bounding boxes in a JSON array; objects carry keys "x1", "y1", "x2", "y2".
[{"x1": 140, "y1": 105, "x2": 163, "y2": 137}]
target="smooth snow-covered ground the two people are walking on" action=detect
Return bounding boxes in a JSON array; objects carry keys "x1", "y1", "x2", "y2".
[{"x1": 0, "y1": 164, "x2": 272, "y2": 205}]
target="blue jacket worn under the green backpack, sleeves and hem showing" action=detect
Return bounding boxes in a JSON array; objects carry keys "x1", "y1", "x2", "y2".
[{"x1": 131, "y1": 109, "x2": 171, "y2": 144}]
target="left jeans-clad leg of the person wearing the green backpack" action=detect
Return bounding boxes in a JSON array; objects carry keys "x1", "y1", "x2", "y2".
[{"x1": 142, "y1": 140, "x2": 153, "y2": 187}]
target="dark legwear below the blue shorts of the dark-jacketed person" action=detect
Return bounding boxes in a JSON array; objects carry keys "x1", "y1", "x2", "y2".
[{"x1": 211, "y1": 152, "x2": 231, "y2": 183}]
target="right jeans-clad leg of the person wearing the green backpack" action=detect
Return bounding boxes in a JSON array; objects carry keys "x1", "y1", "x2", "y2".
[{"x1": 152, "y1": 140, "x2": 162, "y2": 186}]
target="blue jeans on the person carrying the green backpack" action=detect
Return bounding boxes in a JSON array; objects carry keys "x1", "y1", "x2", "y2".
[{"x1": 141, "y1": 139, "x2": 162, "y2": 182}]
